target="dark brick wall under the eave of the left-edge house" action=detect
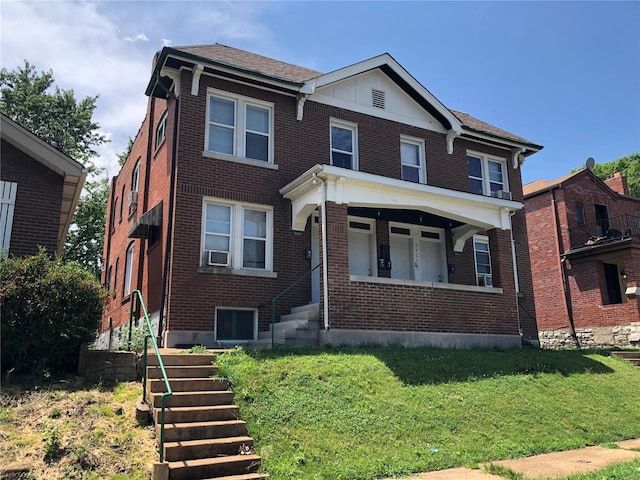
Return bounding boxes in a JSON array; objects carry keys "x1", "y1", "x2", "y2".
[{"x1": 0, "y1": 140, "x2": 64, "y2": 256}]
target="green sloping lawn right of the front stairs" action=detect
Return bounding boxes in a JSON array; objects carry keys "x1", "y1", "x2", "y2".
[{"x1": 218, "y1": 347, "x2": 640, "y2": 480}]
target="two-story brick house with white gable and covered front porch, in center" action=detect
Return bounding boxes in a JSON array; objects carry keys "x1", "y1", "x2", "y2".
[{"x1": 99, "y1": 44, "x2": 542, "y2": 347}]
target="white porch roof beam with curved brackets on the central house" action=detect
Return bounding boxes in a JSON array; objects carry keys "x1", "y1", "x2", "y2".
[{"x1": 280, "y1": 165, "x2": 523, "y2": 231}]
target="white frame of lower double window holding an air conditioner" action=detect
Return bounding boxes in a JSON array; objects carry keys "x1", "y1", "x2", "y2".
[{"x1": 198, "y1": 197, "x2": 273, "y2": 273}]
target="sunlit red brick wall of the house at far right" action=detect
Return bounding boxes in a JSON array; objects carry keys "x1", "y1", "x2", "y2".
[{"x1": 525, "y1": 171, "x2": 640, "y2": 340}]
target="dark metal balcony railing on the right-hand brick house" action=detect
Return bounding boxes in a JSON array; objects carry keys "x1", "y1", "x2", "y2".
[{"x1": 569, "y1": 214, "x2": 640, "y2": 248}]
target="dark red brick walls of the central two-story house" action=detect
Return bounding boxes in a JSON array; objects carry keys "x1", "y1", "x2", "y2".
[{"x1": 105, "y1": 64, "x2": 526, "y2": 342}]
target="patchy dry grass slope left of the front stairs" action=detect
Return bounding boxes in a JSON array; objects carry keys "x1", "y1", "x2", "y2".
[{"x1": 0, "y1": 379, "x2": 157, "y2": 480}]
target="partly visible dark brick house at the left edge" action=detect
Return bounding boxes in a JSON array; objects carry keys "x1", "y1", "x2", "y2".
[{"x1": 0, "y1": 114, "x2": 87, "y2": 257}]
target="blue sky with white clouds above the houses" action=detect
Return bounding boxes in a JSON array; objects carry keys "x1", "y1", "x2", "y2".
[{"x1": 0, "y1": 1, "x2": 640, "y2": 183}]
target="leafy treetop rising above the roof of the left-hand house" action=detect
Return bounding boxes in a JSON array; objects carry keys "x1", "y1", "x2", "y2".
[{"x1": 0, "y1": 60, "x2": 107, "y2": 174}]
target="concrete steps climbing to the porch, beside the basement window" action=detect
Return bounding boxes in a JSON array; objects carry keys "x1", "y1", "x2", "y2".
[{"x1": 250, "y1": 303, "x2": 320, "y2": 348}]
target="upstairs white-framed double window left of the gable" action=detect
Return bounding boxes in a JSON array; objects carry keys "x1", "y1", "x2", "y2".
[{"x1": 205, "y1": 91, "x2": 273, "y2": 163}]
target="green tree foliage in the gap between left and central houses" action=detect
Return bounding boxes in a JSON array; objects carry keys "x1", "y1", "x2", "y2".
[{"x1": 62, "y1": 179, "x2": 109, "y2": 278}]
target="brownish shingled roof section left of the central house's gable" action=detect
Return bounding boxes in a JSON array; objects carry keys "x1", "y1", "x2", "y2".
[{"x1": 172, "y1": 43, "x2": 322, "y2": 83}]
